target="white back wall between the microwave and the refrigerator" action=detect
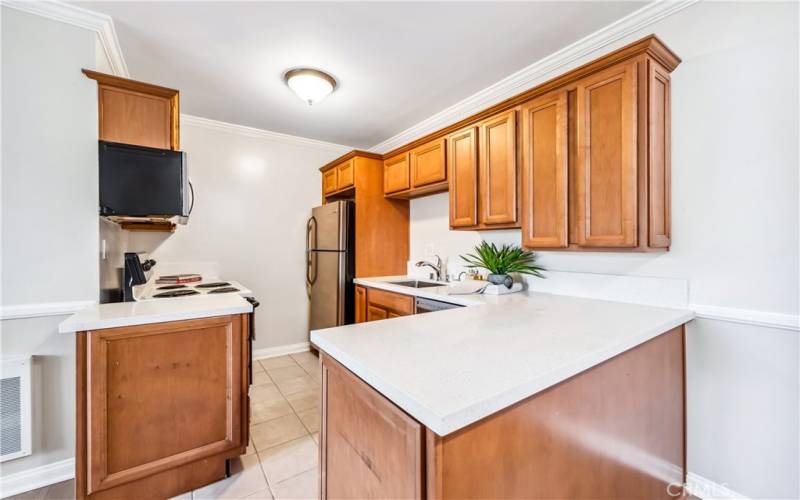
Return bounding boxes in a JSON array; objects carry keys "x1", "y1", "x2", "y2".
[{"x1": 129, "y1": 119, "x2": 345, "y2": 349}]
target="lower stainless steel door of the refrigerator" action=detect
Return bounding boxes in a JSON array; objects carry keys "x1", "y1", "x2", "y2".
[{"x1": 308, "y1": 250, "x2": 346, "y2": 330}]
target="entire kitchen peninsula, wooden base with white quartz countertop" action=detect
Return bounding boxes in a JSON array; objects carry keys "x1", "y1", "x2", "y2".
[{"x1": 311, "y1": 279, "x2": 693, "y2": 499}]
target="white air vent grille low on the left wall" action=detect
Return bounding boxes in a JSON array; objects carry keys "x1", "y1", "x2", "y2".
[{"x1": 0, "y1": 357, "x2": 31, "y2": 462}]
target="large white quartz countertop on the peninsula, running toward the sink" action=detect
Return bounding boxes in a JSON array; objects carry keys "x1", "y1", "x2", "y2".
[{"x1": 311, "y1": 277, "x2": 694, "y2": 436}]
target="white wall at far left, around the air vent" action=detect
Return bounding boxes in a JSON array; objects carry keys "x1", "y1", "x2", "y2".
[{"x1": 0, "y1": 2, "x2": 98, "y2": 484}]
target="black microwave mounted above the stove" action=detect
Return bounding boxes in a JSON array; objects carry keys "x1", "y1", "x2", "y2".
[{"x1": 100, "y1": 141, "x2": 194, "y2": 217}]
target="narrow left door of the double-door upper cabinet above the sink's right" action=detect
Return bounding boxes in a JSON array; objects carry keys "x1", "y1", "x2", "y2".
[{"x1": 447, "y1": 127, "x2": 478, "y2": 227}]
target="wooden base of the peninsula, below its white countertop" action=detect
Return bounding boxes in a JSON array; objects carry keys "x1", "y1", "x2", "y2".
[{"x1": 320, "y1": 326, "x2": 686, "y2": 500}]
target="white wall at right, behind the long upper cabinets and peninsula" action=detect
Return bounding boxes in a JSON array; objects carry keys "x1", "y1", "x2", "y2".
[{"x1": 411, "y1": 2, "x2": 800, "y2": 498}]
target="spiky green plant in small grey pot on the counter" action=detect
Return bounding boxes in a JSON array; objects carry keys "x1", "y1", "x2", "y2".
[{"x1": 461, "y1": 241, "x2": 545, "y2": 288}]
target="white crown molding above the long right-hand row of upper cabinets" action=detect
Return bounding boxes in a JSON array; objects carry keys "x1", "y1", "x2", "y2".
[{"x1": 369, "y1": 0, "x2": 699, "y2": 154}]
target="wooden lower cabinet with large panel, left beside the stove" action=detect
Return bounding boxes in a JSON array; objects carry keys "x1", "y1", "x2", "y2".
[{"x1": 75, "y1": 315, "x2": 250, "y2": 499}]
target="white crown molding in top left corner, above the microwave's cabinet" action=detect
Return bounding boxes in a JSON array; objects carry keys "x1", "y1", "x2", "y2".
[{"x1": 2, "y1": 0, "x2": 130, "y2": 78}]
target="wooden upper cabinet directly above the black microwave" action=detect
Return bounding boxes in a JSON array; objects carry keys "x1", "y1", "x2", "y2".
[{"x1": 83, "y1": 70, "x2": 180, "y2": 150}]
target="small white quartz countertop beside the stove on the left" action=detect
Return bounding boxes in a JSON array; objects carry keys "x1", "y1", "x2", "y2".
[{"x1": 58, "y1": 294, "x2": 253, "y2": 333}]
